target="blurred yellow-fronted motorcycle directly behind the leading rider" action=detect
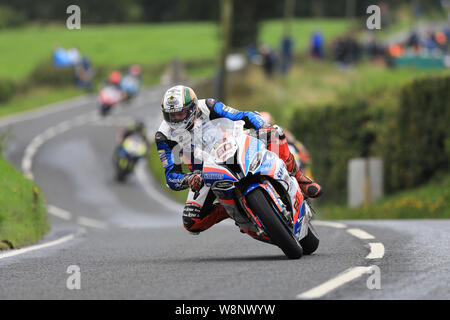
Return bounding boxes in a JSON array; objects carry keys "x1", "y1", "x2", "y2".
[{"x1": 113, "y1": 134, "x2": 148, "y2": 182}]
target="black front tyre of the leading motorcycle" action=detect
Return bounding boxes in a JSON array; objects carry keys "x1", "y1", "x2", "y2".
[{"x1": 246, "y1": 188, "x2": 303, "y2": 259}]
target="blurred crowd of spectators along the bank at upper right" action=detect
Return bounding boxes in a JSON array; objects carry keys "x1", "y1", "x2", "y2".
[{"x1": 247, "y1": 20, "x2": 450, "y2": 79}]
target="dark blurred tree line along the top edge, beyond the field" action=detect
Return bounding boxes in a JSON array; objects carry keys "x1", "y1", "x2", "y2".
[{"x1": 0, "y1": 0, "x2": 434, "y2": 24}]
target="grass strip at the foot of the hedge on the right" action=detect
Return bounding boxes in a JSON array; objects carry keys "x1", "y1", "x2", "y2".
[{"x1": 318, "y1": 174, "x2": 450, "y2": 220}]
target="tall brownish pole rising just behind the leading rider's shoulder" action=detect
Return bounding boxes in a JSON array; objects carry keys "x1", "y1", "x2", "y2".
[{"x1": 215, "y1": 0, "x2": 233, "y2": 101}]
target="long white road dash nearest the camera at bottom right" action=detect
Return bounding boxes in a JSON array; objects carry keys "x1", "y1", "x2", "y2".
[{"x1": 296, "y1": 267, "x2": 372, "y2": 299}]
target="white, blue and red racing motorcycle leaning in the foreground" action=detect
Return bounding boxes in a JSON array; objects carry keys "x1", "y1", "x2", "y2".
[{"x1": 194, "y1": 118, "x2": 319, "y2": 259}]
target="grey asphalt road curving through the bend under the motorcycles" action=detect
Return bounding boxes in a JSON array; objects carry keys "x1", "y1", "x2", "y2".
[{"x1": 0, "y1": 88, "x2": 450, "y2": 299}]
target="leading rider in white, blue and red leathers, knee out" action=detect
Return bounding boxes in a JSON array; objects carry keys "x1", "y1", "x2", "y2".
[{"x1": 155, "y1": 85, "x2": 322, "y2": 241}]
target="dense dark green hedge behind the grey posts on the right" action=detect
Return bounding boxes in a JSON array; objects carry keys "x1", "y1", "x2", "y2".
[{"x1": 290, "y1": 76, "x2": 450, "y2": 203}]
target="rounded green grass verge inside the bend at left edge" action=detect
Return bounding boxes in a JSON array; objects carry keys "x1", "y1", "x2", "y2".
[{"x1": 0, "y1": 157, "x2": 49, "y2": 250}]
